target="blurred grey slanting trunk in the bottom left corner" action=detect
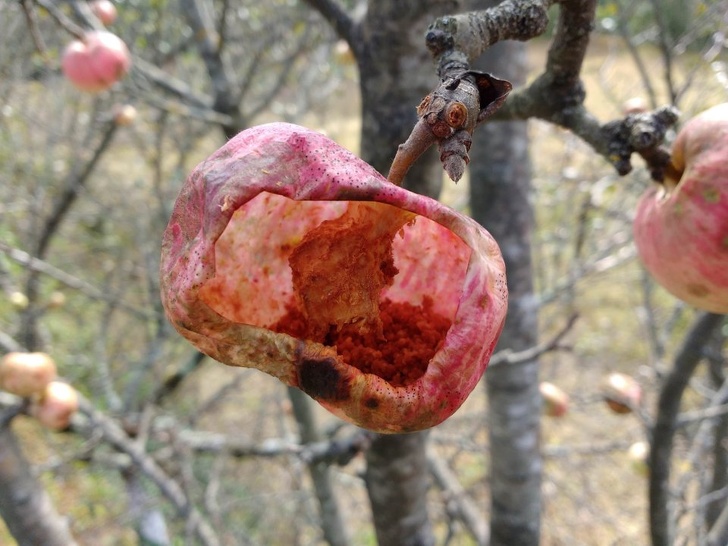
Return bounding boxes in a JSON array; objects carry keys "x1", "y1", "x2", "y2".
[{"x1": 0, "y1": 426, "x2": 76, "y2": 546}]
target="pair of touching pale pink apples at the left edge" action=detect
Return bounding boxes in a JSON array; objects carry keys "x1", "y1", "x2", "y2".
[{"x1": 0, "y1": 352, "x2": 78, "y2": 430}]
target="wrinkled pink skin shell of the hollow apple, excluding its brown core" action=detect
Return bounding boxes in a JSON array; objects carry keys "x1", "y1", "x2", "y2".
[{"x1": 160, "y1": 123, "x2": 507, "y2": 433}]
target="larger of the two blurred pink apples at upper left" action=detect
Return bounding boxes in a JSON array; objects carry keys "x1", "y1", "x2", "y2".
[{"x1": 61, "y1": 30, "x2": 131, "y2": 93}]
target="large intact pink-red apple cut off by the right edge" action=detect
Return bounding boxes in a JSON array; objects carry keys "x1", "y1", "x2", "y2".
[{"x1": 634, "y1": 104, "x2": 728, "y2": 313}]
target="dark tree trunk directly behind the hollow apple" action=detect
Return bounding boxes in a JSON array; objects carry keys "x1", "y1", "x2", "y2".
[{"x1": 351, "y1": 0, "x2": 470, "y2": 546}]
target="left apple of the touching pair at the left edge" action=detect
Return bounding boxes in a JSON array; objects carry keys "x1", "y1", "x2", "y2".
[{"x1": 0, "y1": 352, "x2": 56, "y2": 397}]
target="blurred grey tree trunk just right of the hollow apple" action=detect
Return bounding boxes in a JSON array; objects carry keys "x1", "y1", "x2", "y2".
[{"x1": 470, "y1": 30, "x2": 541, "y2": 546}]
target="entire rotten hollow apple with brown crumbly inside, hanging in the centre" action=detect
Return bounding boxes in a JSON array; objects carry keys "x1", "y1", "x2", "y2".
[{"x1": 160, "y1": 123, "x2": 507, "y2": 433}]
